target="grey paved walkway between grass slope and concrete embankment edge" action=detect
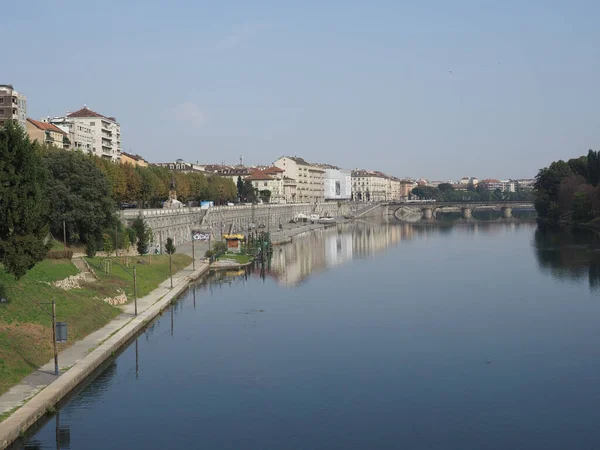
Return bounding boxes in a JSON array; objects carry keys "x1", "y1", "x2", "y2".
[{"x1": 0, "y1": 256, "x2": 208, "y2": 415}]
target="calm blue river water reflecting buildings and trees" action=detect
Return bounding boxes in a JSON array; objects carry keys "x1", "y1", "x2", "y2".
[{"x1": 15, "y1": 221, "x2": 600, "y2": 450}]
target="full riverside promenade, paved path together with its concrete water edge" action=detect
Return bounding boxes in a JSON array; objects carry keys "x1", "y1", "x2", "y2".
[{"x1": 0, "y1": 258, "x2": 209, "y2": 449}]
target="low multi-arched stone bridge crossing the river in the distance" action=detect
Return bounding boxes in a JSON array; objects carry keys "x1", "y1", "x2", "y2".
[{"x1": 387, "y1": 201, "x2": 533, "y2": 219}]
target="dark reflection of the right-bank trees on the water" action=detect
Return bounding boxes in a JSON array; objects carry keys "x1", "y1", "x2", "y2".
[{"x1": 533, "y1": 225, "x2": 600, "y2": 291}]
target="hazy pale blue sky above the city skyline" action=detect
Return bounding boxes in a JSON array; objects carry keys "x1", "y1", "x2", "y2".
[{"x1": 5, "y1": 0, "x2": 600, "y2": 179}]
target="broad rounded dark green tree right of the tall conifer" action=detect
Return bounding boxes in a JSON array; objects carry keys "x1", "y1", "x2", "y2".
[{"x1": 45, "y1": 150, "x2": 116, "y2": 241}]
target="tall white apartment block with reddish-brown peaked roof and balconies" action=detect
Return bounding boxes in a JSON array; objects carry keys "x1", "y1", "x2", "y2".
[{"x1": 50, "y1": 105, "x2": 122, "y2": 162}]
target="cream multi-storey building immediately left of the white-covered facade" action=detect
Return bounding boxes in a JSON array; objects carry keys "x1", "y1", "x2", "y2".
[{"x1": 273, "y1": 156, "x2": 325, "y2": 203}]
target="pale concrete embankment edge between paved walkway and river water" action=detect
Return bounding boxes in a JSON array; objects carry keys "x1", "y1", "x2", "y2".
[{"x1": 0, "y1": 264, "x2": 209, "y2": 449}]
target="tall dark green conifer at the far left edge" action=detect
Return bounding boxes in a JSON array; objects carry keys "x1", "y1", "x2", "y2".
[{"x1": 0, "y1": 121, "x2": 49, "y2": 279}]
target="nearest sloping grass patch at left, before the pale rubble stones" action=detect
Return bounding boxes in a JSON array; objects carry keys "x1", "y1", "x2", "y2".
[{"x1": 0, "y1": 260, "x2": 120, "y2": 394}]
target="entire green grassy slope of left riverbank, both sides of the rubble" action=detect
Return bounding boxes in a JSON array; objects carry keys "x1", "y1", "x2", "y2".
[{"x1": 0, "y1": 254, "x2": 191, "y2": 394}]
